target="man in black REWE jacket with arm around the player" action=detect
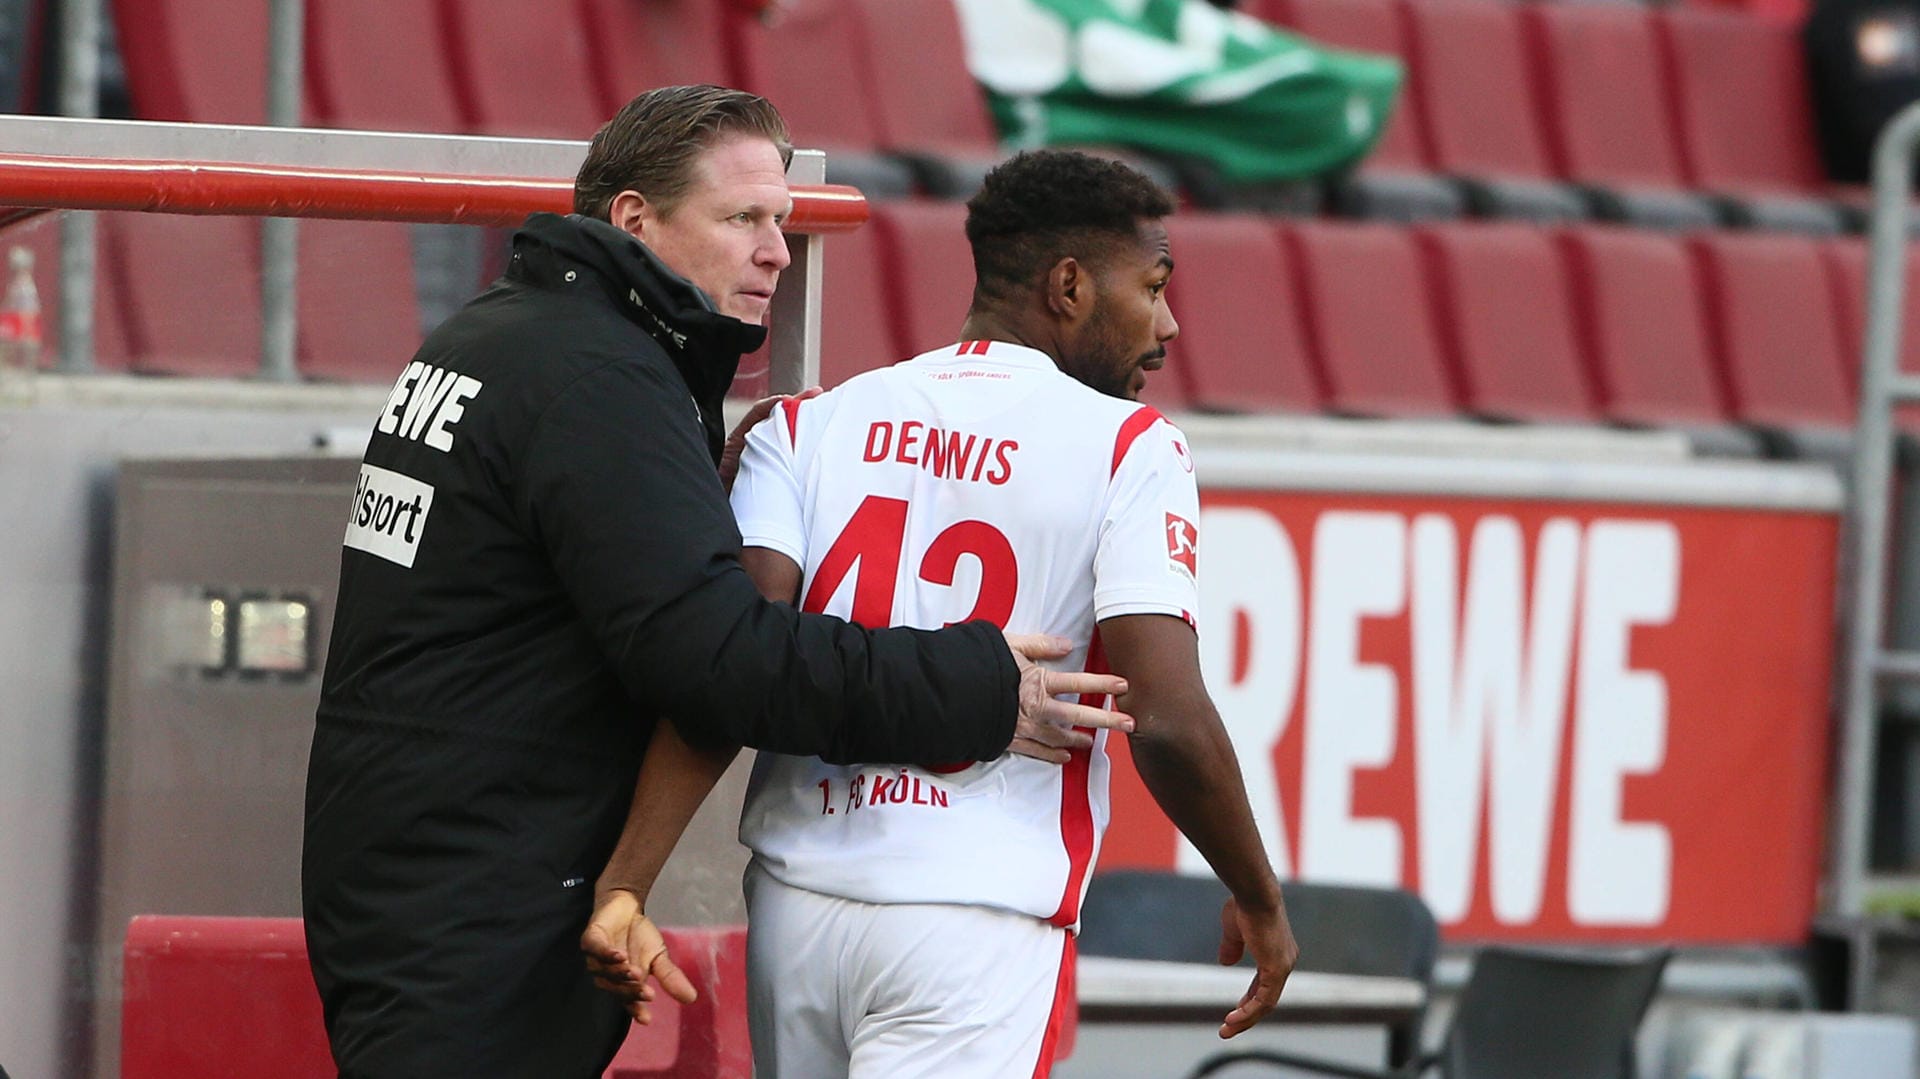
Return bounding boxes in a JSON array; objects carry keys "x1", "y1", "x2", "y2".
[{"x1": 301, "y1": 86, "x2": 1127, "y2": 1079}]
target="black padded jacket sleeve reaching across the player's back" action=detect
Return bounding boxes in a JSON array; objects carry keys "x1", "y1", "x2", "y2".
[{"x1": 516, "y1": 359, "x2": 1020, "y2": 764}]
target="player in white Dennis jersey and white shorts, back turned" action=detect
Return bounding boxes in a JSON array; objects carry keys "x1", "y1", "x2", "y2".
[{"x1": 582, "y1": 152, "x2": 1298, "y2": 1079}]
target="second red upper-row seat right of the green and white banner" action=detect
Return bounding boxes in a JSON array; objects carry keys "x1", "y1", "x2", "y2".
[{"x1": 1405, "y1": 0, "x2": 1586, "y2": 223}]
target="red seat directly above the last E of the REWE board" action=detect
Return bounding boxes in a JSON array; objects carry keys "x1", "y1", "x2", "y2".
[{"x1": 1561, "y1": 227, "x2": 1732, "y2": 426}]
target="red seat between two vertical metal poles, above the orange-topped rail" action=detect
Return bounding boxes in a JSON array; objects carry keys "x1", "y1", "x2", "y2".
[{"x1": 111, "y1": 0, "x2": 267, "y2": 123}]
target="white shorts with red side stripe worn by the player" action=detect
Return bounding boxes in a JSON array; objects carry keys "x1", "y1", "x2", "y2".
[{"x1": 747, "y1": 864, "x2": 1073, "y2": 1079}]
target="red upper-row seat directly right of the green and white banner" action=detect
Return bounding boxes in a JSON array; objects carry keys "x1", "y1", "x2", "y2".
[{"x1": 1256, "y1": 0, "x2": 1465, "y2": 223}]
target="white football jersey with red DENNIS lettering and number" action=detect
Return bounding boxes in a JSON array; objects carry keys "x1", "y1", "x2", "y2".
[{"x1": 733, "y1": 342, "x2": 1200, "y2": 927}]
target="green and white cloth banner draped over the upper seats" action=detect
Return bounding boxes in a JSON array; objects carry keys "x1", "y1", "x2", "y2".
[{"x1": 956, "y1": 0, "x2": 1404, "y2": 180}]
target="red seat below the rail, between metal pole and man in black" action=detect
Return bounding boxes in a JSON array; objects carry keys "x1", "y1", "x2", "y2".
[{"x1": 298, "y1": 221, "x2": 420, "y2": 382}]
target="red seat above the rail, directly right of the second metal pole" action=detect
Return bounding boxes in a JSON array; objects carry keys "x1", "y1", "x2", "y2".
[{"x1": 307, "y1": 0, "x2": 468, "y2": 134}]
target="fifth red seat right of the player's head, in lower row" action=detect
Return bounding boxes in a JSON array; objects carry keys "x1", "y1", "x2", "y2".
[{"x1": 1693, "y1": 232, "x2": 1853, "y2": 428}]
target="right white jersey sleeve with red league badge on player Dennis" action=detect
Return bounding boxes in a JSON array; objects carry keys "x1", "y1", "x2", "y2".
[{"x1": 1092, "y1": 420, "x2": 1200, "y2": 622}]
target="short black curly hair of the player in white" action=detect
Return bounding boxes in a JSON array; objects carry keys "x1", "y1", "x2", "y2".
[{"x1": 966, "y1": 150, "x2": 1173, "y2": 298}]
